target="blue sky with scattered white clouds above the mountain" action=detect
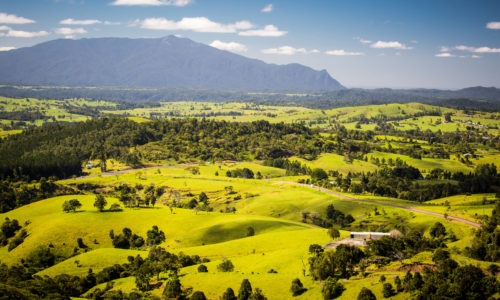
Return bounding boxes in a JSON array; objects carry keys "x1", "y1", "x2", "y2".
[{"x1": 0, "y1": 0, "x2": 500, "y2": 89}]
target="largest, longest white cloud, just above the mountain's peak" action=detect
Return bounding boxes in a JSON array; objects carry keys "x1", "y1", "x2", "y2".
[{"x1": 140, "y1": 17, "x2": 254, "y2": 33}]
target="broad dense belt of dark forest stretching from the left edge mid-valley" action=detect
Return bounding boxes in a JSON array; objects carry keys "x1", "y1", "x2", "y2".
[{"x1": 0, "y1": 118, "x2": 321, "y2": 179}]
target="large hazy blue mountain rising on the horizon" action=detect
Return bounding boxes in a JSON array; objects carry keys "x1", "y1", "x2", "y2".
[{"x1": 0, "y1": 36, "x2": 342, "y2": 90}]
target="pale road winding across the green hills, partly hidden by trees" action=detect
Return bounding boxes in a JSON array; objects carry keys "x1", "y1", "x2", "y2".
[{"x1": 76, "y1": 163, "x2": 481, "y2": 228}]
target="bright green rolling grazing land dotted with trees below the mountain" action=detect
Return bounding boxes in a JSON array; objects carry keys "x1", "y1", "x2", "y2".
[{"x1": 0, "y1": 97, "x2": 500, "y2": 299}]
